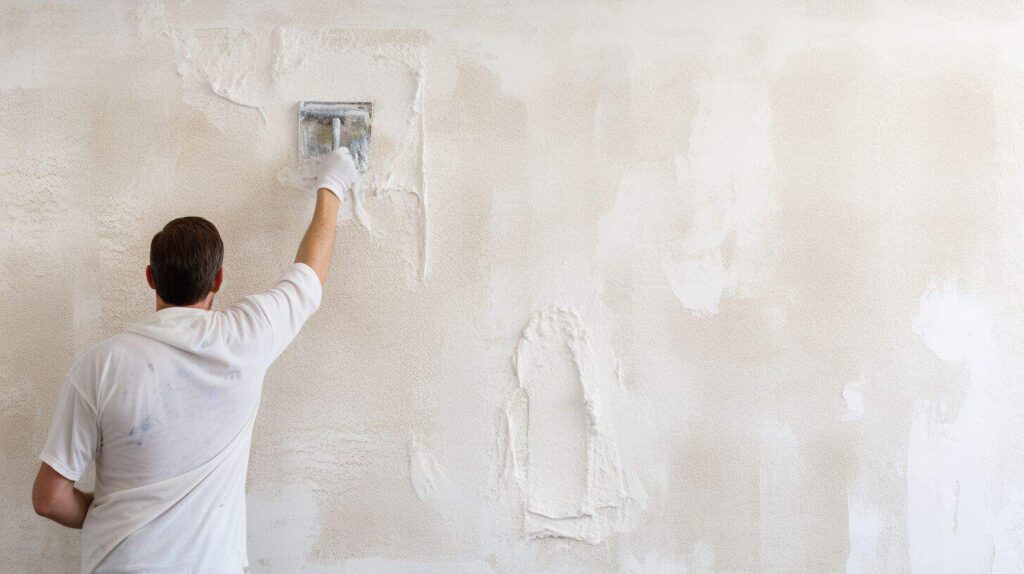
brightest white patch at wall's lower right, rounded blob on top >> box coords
[906,285,1007,574]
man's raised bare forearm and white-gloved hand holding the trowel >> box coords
[295,147,359,284]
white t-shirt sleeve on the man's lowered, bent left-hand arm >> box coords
[39,377,99,481]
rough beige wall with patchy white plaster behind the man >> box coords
[0,0,1024,574]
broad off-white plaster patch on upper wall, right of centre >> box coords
[596,71,774,315]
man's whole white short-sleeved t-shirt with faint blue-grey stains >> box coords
[40,263,322,574]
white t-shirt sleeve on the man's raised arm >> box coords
[230,263,324,361]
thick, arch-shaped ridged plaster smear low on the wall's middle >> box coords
[502,307,643,543]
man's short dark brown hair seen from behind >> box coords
[150,217,224,305]
